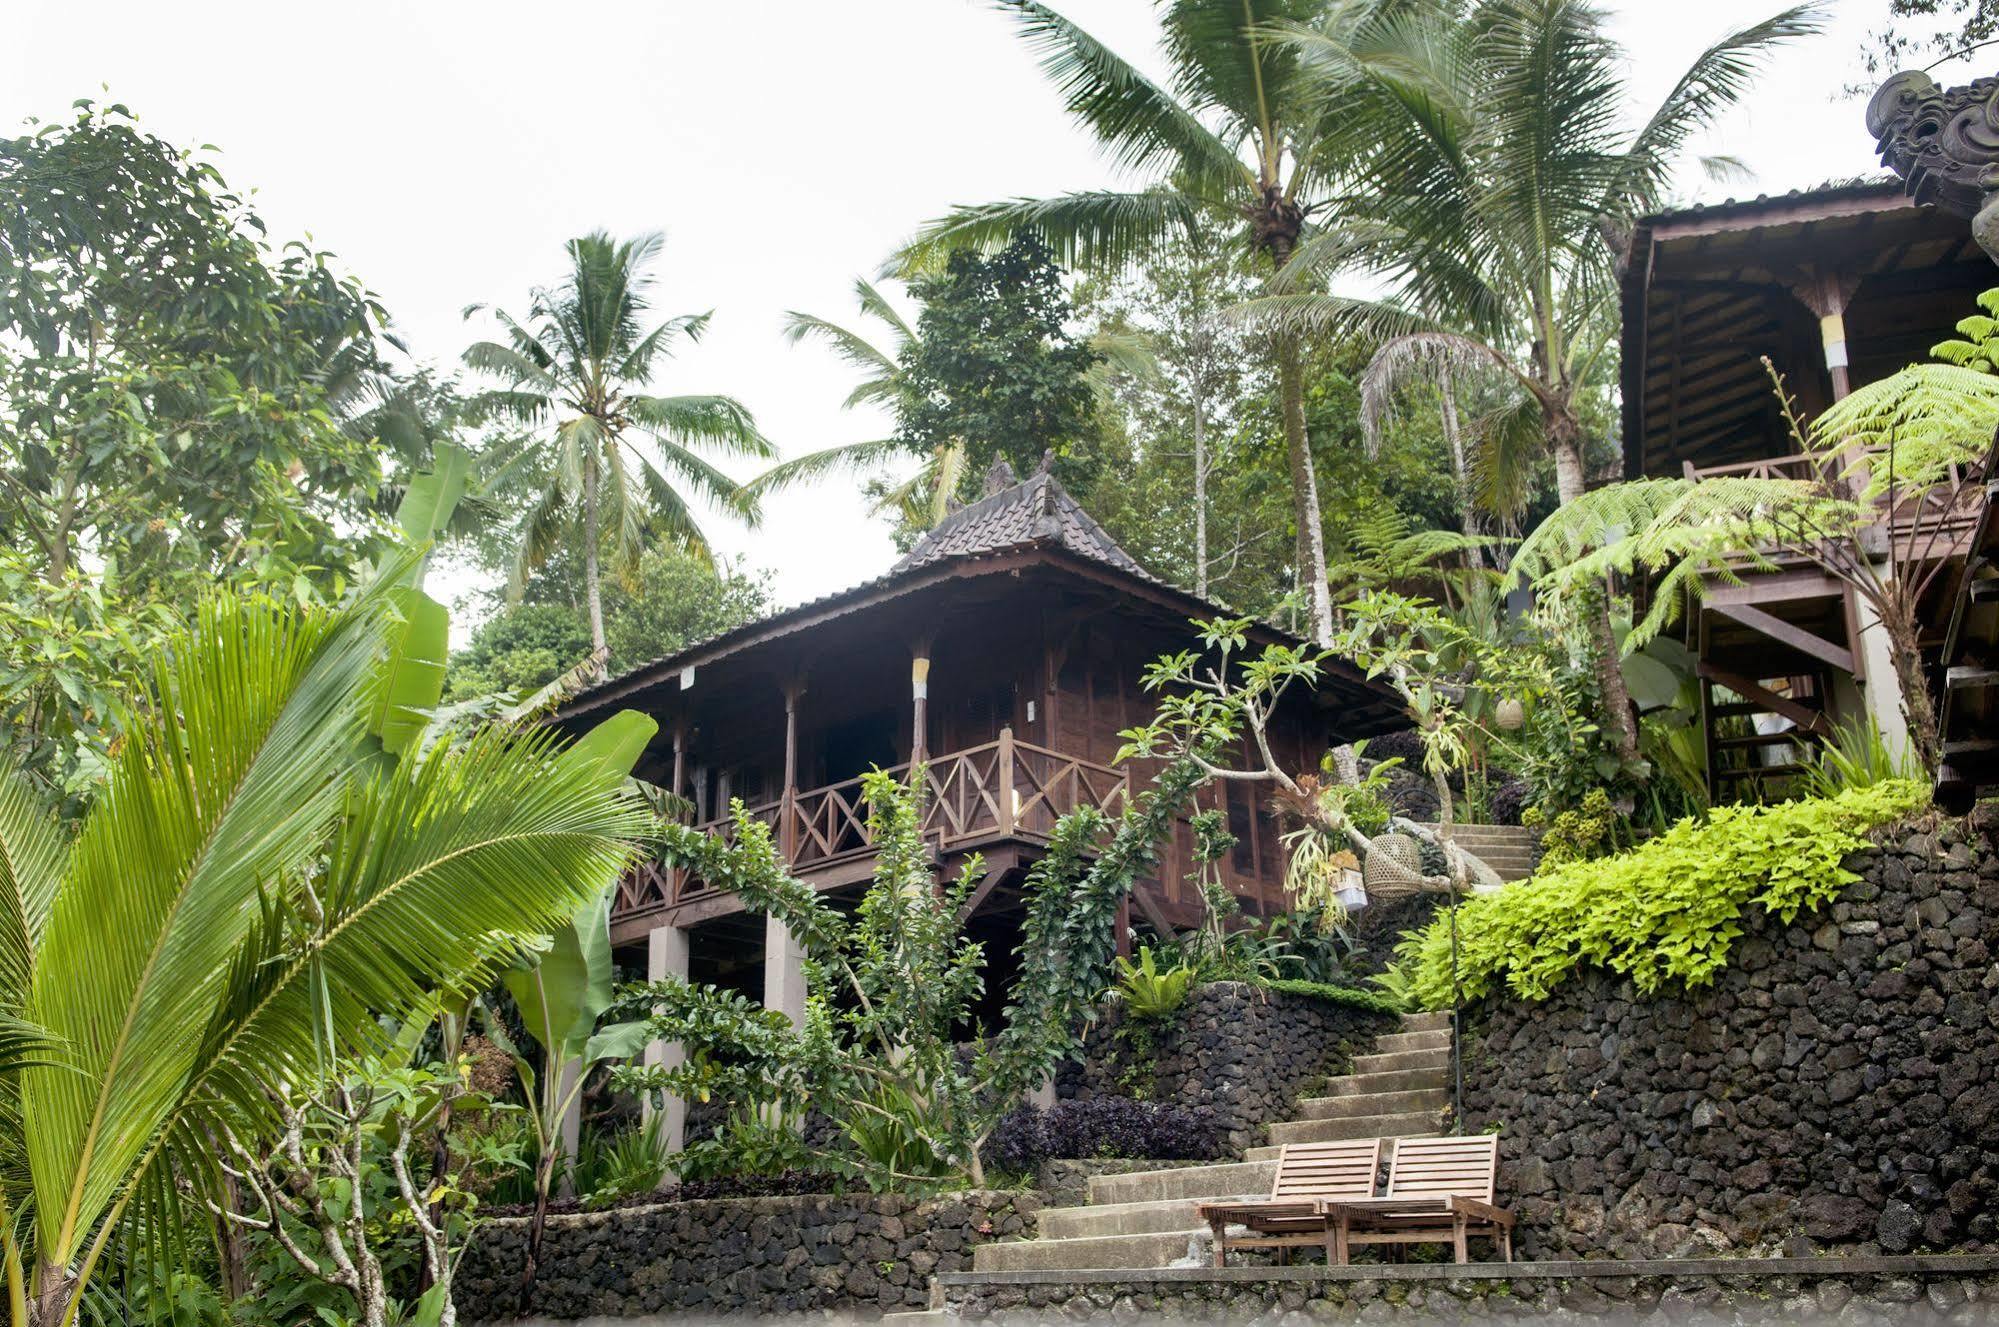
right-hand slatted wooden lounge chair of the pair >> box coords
[1325,1133,1513,1263]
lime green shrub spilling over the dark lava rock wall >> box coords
[1399,779,1929,1009]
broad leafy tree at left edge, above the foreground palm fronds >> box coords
[0,102,450,809]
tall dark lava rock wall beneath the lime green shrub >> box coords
[1463,815,1999,1259]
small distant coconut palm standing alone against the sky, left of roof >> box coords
[466,230,776,667]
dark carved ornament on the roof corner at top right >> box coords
[1867,70,1999,262]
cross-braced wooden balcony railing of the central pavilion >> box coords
[612,729,1131,915]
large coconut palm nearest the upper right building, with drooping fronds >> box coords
[1251,0,1817,757]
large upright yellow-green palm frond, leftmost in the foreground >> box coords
[22,594,384,1265]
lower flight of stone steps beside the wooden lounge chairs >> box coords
[972,1013,1451,1271]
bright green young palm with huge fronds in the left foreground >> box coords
[0,560,652,1327]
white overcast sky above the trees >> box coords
[0,0,1887,623]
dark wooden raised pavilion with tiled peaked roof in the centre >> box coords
[556,462,1405,1039]
